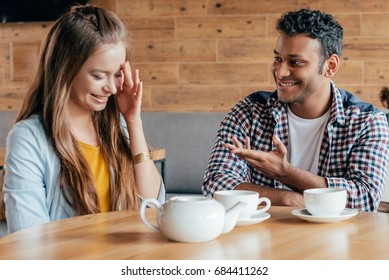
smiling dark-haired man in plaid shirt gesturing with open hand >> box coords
[203,9,389,211]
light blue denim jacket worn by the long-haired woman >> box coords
[0,115,165,237]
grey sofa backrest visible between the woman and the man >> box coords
[142,112,226,197]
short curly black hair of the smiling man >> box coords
[276,9,343,72]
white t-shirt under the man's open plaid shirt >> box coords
[288,107,330,174]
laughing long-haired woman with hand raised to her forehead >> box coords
[0,5,165,236]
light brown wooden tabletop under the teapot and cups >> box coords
[0,206,389,260]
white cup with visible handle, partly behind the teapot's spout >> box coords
[213,190,271,220]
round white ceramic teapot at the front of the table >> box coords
[140,195,244,242]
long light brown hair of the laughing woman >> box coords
[0,5,139,219]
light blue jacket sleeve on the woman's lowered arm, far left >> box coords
[3,123,50,233]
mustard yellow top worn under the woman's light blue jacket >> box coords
[78,142,111,212]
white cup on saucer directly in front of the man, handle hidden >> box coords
[304,188,347,217]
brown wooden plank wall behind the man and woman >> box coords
[0,0,389,112]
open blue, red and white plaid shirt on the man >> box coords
[203,83,389,211]
